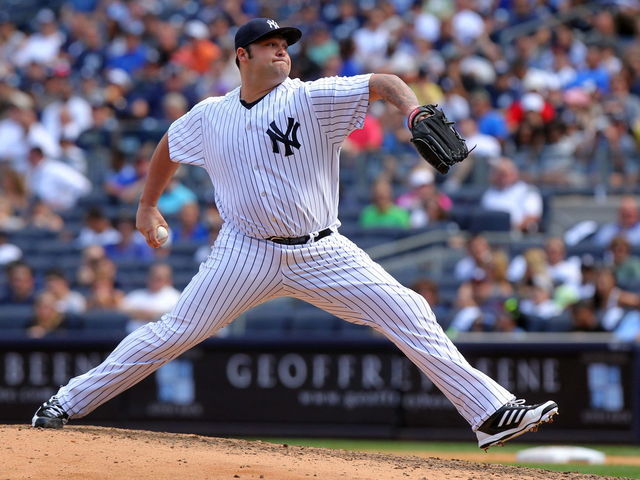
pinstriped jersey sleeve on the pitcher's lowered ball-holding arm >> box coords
[169,99,212,167]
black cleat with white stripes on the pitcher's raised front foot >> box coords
[476,399,558,451]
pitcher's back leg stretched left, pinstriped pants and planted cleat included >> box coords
[33,231,281,428]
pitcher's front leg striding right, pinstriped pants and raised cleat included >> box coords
[287,234,557,448]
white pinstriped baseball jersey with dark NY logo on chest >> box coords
[169,75,370,238]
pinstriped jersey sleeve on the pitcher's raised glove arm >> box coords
[307,73,371,142]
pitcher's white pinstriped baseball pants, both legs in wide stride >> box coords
[57,225,514,430]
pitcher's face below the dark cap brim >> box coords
[243,36,291,81]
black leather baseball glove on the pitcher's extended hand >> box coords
[409,105,469,175]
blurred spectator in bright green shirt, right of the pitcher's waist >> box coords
[360,177,410,228]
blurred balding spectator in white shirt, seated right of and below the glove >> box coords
[480,157,542,233]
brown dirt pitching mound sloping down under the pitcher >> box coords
[0,425,605,480]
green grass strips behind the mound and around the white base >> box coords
[254,438,640,479]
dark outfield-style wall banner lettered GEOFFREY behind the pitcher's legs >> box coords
[0,339,640,441]
